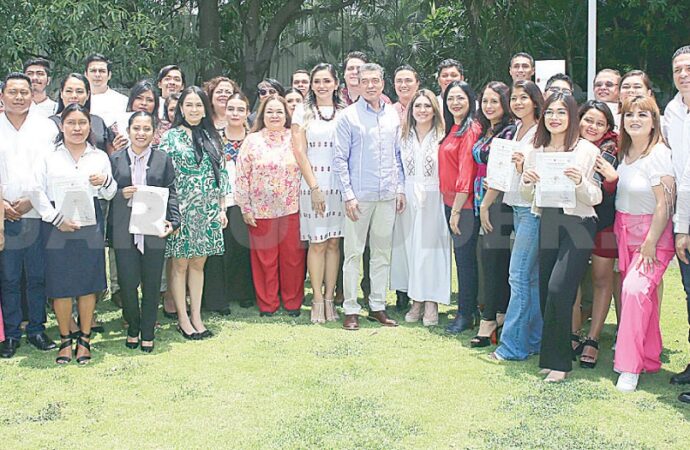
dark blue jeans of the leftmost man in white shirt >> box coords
[0,219,46,339]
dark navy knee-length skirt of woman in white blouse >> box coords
[43,198,106,298]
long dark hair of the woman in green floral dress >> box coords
[172,86,223,187]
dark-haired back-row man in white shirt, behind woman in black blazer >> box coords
[84,53,129,125]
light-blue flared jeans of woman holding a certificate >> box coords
[496,206,543,360]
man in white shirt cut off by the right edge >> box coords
[662,45,690,403]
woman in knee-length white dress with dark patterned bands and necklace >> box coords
[292,63,345,323]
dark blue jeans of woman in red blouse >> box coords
[445,205,479,317]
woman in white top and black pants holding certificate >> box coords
[520,93,601,382]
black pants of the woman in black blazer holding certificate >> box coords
[115,243,165,341]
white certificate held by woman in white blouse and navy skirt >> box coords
[50,176,96,227]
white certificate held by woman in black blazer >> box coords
[129,186,170,236]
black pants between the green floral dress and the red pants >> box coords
[202,206,256,311]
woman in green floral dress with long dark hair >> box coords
[160,86,230,339]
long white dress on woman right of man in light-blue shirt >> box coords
[391,130,451,305]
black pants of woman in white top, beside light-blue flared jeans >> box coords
[539,208,596,372]
